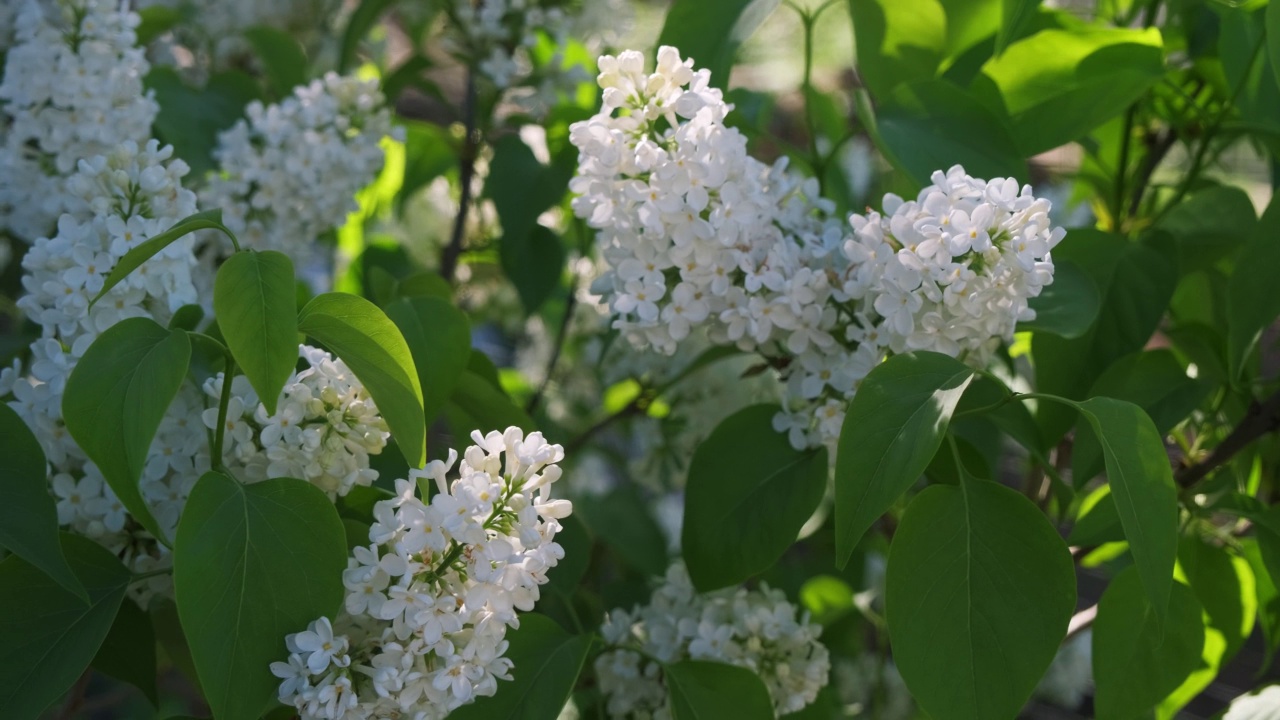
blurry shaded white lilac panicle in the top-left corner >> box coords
[0,0,159,242]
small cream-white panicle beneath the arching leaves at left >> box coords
[202,345,390,498]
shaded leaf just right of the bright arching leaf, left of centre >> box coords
[387,297,478,429]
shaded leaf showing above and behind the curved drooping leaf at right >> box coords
[1071,350,1208,487]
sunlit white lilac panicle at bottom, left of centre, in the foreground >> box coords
[271,428,572,720]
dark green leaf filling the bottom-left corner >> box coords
[0,534,129,720]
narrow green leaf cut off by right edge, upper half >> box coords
[1226,196,1280,380]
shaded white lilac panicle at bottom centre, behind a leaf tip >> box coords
[595,562,831,720]
